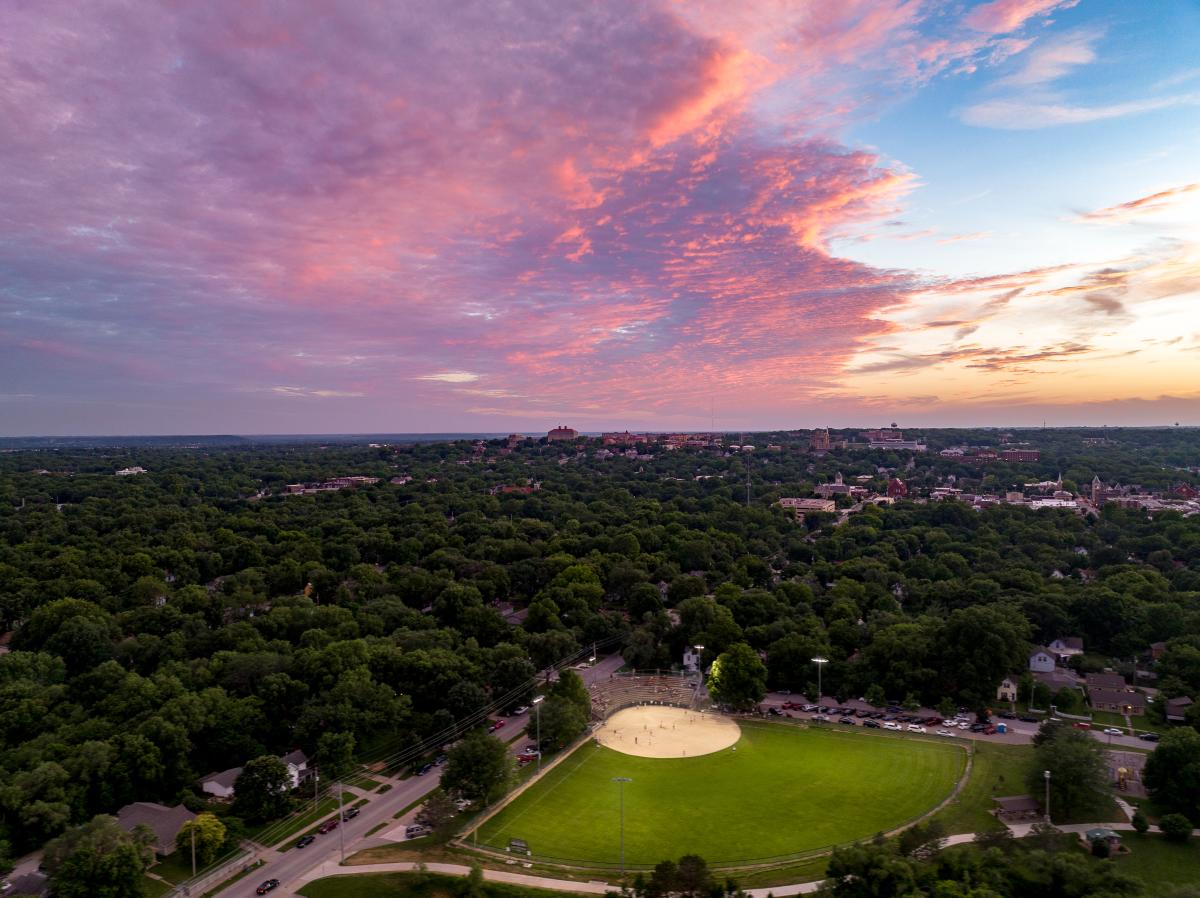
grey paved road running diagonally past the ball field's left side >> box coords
[236,655,624,898]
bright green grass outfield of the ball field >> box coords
[472,724,966,867]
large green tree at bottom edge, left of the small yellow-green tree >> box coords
[44,814,154,898]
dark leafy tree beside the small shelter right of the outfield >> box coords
[1028,724,1109,820]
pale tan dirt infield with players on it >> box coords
[595,705,742,758]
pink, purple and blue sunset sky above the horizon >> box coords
[0,0,1200,435]
